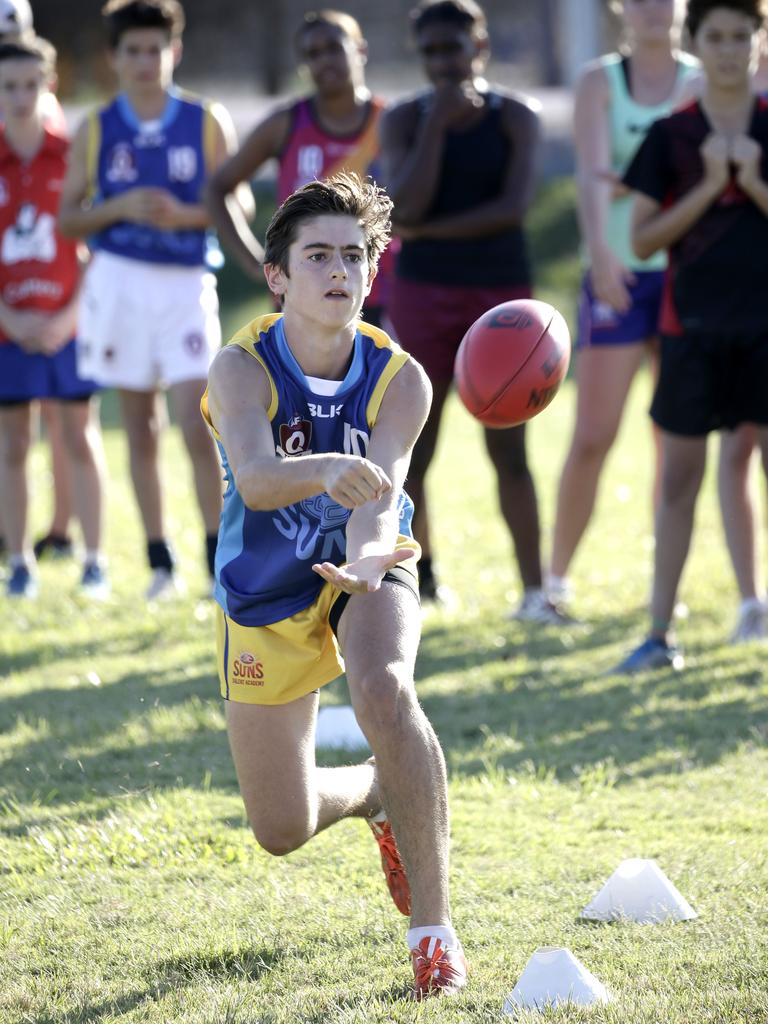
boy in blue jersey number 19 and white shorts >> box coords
[60,0,249,600]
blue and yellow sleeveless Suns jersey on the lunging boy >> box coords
[201,313,414,626]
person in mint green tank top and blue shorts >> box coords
[547,0,765,639]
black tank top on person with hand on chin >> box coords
[395,93,530,287]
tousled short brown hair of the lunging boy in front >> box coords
[264,172,392,273]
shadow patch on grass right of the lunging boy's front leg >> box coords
[418,612,768,784]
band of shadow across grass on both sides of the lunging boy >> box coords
[0,598,768,811]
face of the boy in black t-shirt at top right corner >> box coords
[693,6,761,89]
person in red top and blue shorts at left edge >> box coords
[0,34,108,597]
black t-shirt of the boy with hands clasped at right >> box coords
[624,97,768,334]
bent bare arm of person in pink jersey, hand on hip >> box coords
[206,109,291,280]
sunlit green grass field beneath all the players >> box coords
[0,180,768,1024]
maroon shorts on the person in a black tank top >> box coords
[387,276,530,381]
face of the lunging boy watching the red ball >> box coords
[264,214,375,330]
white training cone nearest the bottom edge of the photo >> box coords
[504,946,609,1014]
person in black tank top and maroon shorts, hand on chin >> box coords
[382,0,560,623]
